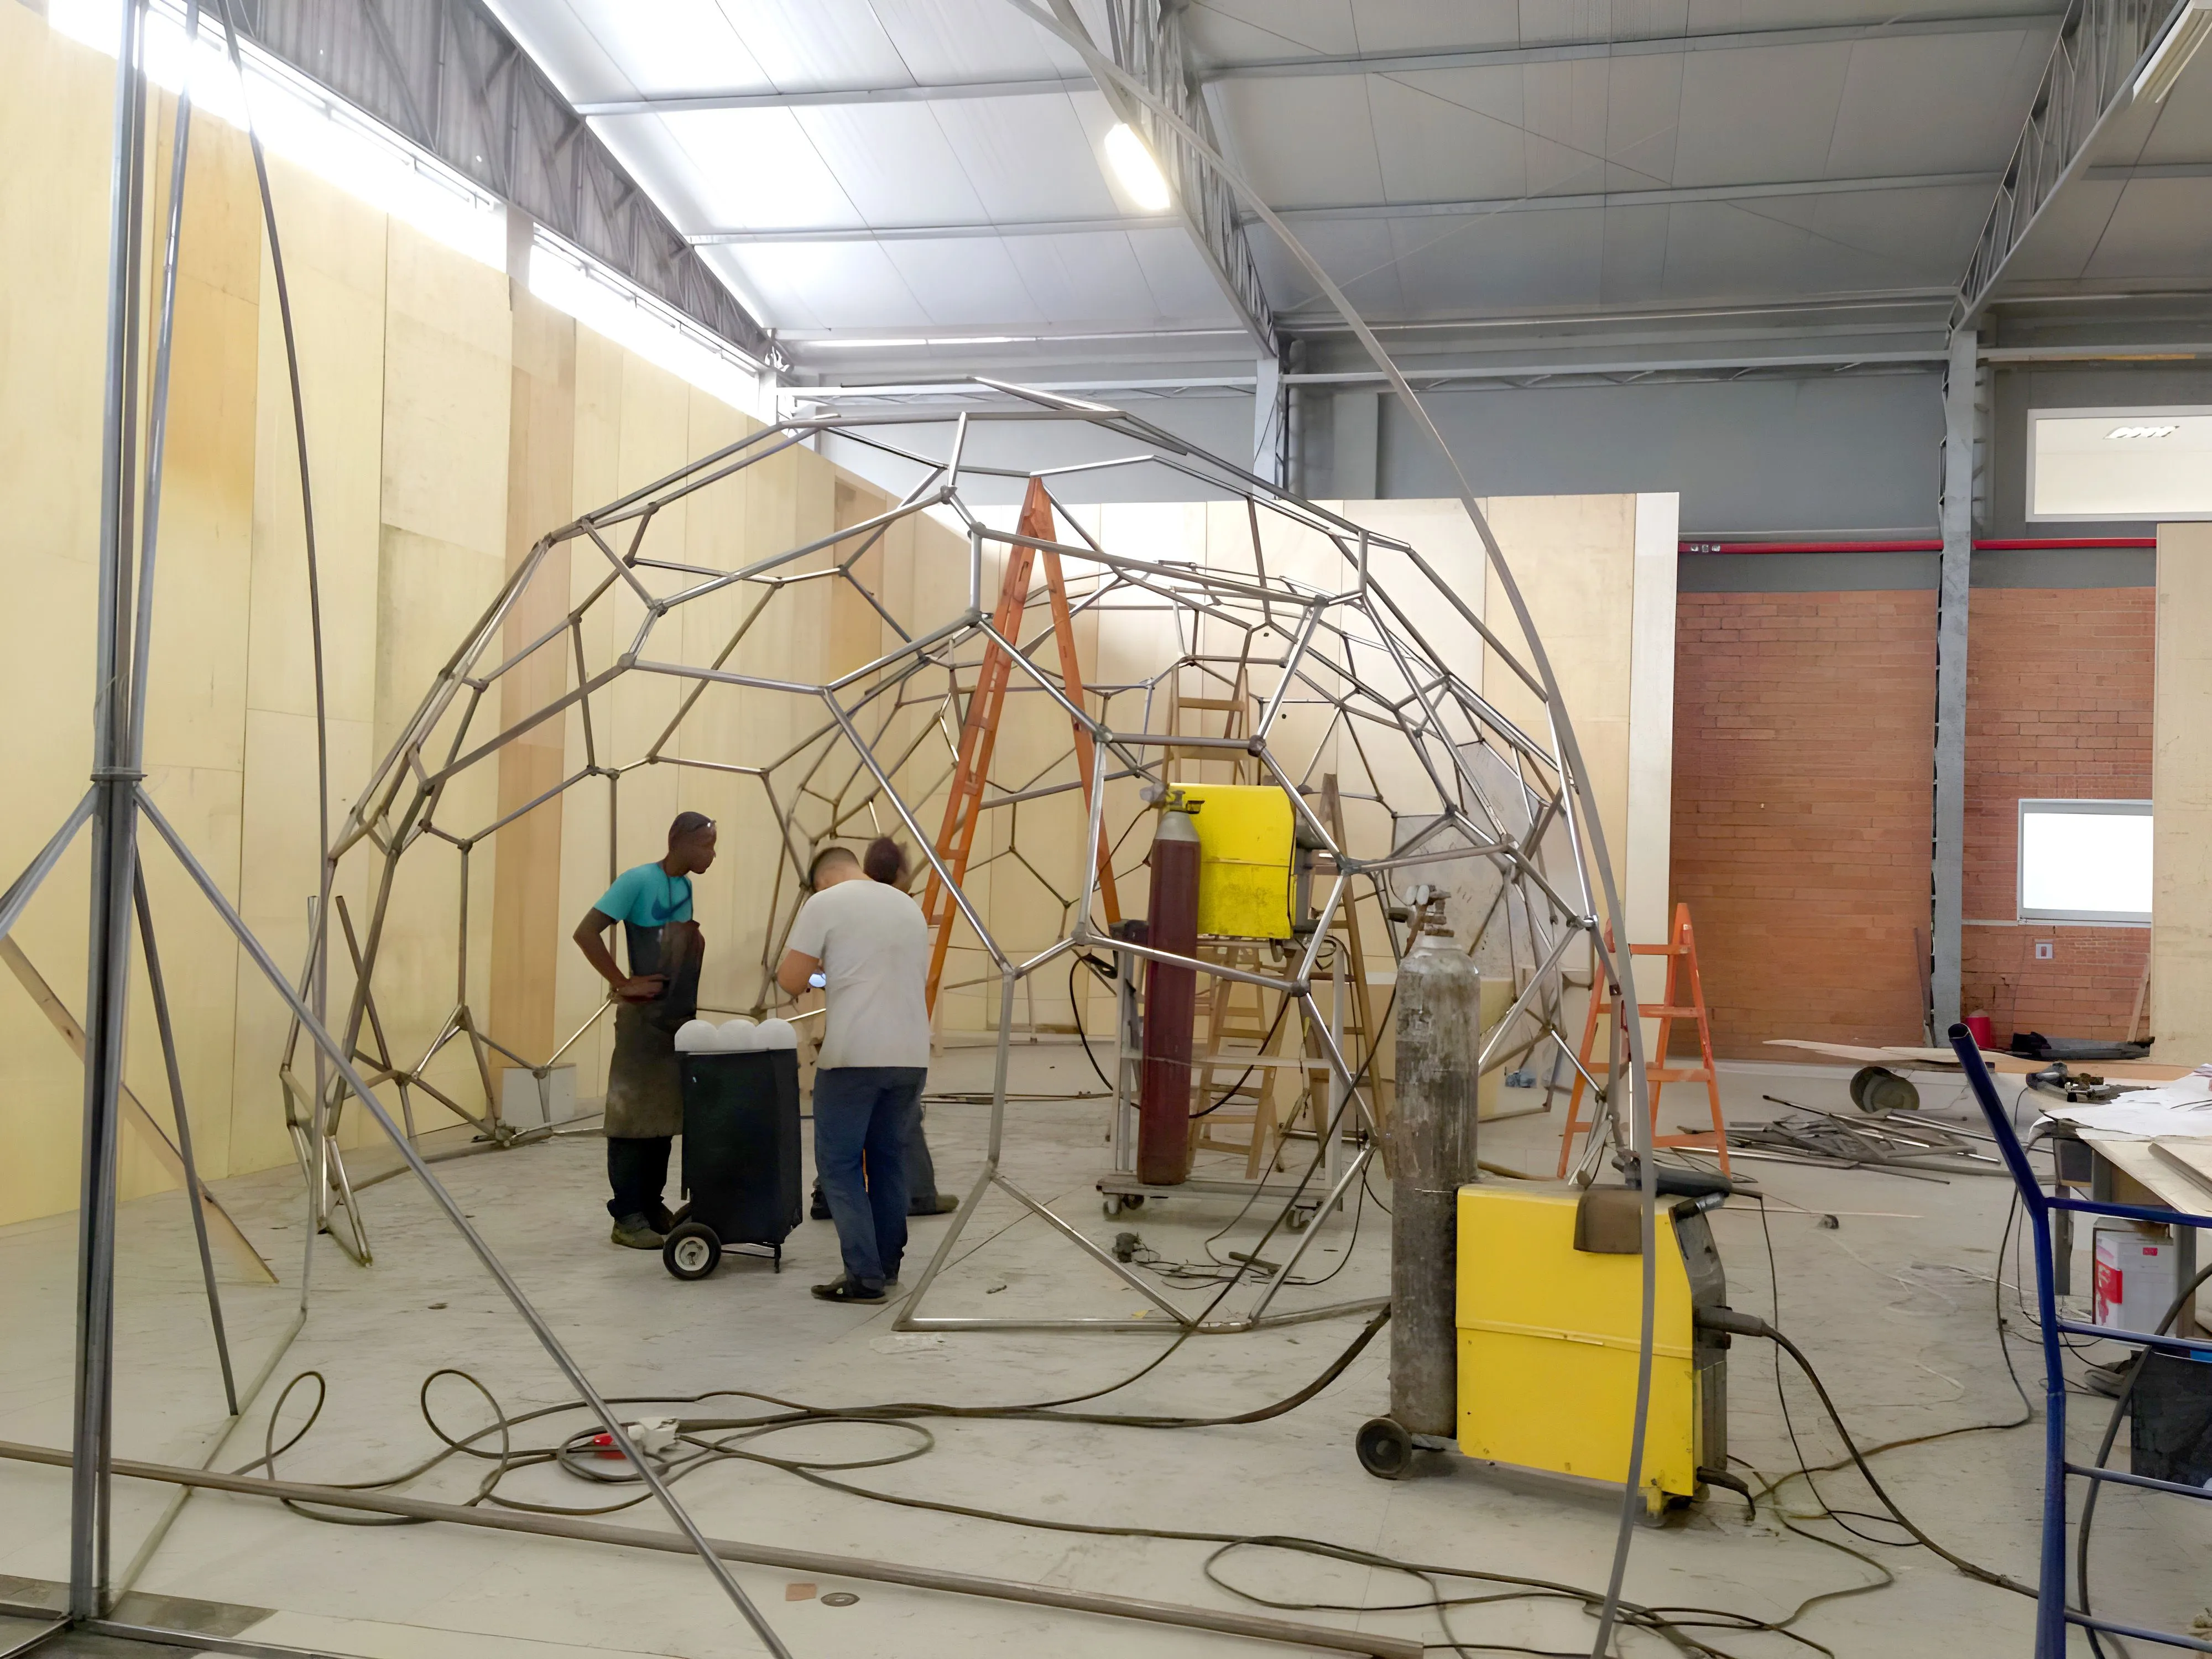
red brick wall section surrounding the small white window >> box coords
[1962,588,2154,1042]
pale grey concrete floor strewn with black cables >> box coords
[0,1046,2212,1659]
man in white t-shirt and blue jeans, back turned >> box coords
[776,847,929,1303]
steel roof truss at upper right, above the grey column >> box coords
[1960,0,2183,327]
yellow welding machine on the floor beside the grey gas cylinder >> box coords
[1455,1170,1728,1513]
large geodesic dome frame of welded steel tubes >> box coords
[285,383,1604,1329]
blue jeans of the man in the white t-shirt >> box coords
[814,1066,929,1290]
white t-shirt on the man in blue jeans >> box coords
[790,876,929,1071]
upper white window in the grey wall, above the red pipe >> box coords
[2028,409,2212,522]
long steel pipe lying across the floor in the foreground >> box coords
[0,1440,1422,1659]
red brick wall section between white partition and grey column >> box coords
[1672,591,1938,1060]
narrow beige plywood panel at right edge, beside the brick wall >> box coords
[2150,524,2212,1066]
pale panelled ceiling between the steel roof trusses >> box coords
[495,0,2212,365]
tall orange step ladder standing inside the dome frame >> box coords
[922,478,1121,1013]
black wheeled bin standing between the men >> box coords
[661,1048,803,1279]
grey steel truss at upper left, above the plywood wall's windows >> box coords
[239,0,787,369]
